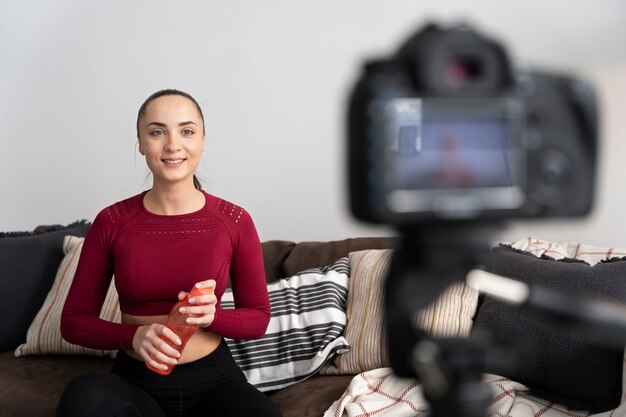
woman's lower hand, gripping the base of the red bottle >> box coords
[133,323,182,370]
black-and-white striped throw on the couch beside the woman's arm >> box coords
[222,257,350,391]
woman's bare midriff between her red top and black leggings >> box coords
[122,313,222,364]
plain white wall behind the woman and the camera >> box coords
[0,0,626,246]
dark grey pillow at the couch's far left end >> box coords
[0,222,89,351]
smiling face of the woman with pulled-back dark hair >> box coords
[139,95,204,185]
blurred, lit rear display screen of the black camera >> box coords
[385,98,524,217]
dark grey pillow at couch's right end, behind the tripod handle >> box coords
[472,245,626,413]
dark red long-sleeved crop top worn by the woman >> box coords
[61,192,270,350]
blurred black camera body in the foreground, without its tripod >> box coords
[347,25,598,226]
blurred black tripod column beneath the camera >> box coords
[385,225,500,417]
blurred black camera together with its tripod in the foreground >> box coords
[347,24,598,417]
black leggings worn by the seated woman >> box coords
[56,340,281,417]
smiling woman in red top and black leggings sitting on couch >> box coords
[57,90,280,417]
